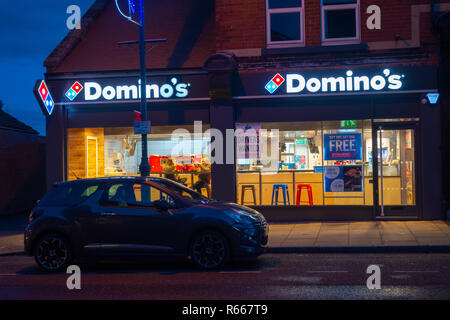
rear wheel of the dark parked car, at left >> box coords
[34,234,73,272]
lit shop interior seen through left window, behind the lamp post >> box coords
[67,126,211,196]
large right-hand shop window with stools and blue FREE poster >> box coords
[236,120,373,206]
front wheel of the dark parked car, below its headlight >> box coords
[190,230,230,269]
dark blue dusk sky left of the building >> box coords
[0,0,95,135]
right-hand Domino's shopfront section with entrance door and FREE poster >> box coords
[233,66,441,221]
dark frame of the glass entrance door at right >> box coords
[372,119,423,219]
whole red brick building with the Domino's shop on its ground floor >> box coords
[37,0,450,220]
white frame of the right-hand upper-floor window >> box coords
[320,0,361,46]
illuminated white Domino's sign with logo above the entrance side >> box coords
[265,69,405,94]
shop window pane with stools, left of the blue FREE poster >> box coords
[236,122,323,206]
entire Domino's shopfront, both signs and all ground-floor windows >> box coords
[35,62,441,221]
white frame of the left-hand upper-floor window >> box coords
[266,0,305,48]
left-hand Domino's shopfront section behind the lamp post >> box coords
[35,70,215,196]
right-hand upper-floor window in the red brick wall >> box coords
[321,0,360,45]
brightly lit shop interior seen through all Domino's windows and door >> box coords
[67,119,417,206]
